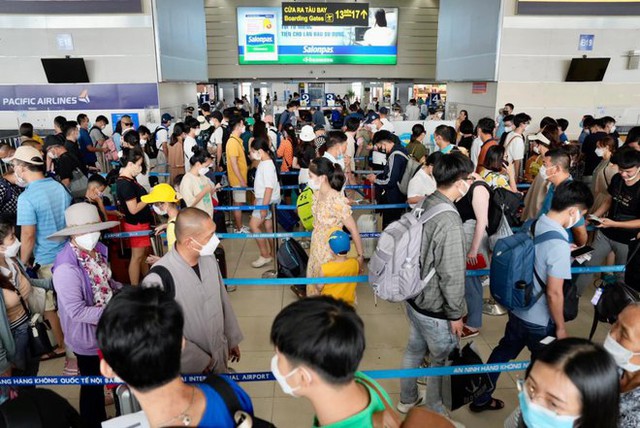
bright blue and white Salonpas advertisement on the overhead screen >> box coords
[238,7,398,65]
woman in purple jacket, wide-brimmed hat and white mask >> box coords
[49,202,122,428]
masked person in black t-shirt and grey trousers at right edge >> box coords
[578,148,640,294]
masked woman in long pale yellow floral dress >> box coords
[304,157,364,297]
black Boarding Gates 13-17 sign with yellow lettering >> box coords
[282,2,369,27]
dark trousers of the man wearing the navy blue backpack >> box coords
[473,312,556,406]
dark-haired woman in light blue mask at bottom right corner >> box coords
[504,338,620,428]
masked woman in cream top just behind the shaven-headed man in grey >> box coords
[180,146,216,218]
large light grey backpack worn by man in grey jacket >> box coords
[369,203,457,302]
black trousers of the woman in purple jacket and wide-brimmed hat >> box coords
[76,354,107,428]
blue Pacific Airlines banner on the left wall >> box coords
[0,83,158,111]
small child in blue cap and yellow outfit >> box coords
[318,229,360,306]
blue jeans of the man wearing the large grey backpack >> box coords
[400,304,458,414]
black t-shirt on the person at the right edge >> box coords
[601,174,640,244]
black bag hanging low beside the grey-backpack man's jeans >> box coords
[442,342,493,411]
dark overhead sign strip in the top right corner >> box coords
[518,0,640,15]
